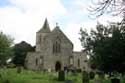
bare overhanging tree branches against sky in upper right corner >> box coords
[88,0,125,17]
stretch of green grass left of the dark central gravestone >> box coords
[0,69,62,83]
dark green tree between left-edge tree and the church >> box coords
[13,41,34,66]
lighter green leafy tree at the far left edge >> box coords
[0,32,13,65]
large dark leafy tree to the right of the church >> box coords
[80,23,125,72]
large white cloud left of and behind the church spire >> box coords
[0,0,66,45]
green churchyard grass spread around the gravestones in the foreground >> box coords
[0,68,123,83]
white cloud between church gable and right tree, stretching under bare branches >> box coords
[64,16,122,51]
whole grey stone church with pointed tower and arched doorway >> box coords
[25,19,88,71]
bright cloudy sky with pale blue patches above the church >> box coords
[0,0,121,51]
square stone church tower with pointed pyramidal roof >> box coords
[36,18,51,52]
